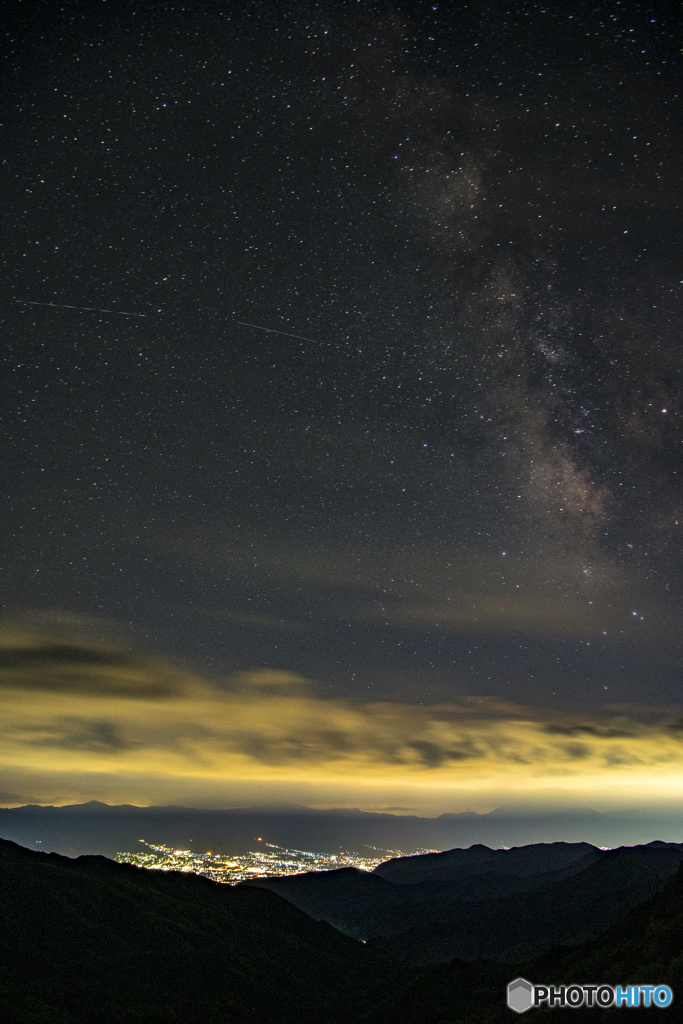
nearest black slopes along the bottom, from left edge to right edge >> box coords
[0,842,683,1024]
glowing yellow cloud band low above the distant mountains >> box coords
[0,618,683,811]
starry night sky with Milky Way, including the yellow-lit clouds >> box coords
[0,0,683,813]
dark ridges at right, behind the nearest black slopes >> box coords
[243,843,683,967]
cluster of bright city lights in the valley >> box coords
[116,839,433,886]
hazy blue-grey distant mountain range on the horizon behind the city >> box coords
[0,801,683,857]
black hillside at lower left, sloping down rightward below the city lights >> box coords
[0,841,397,1024]
